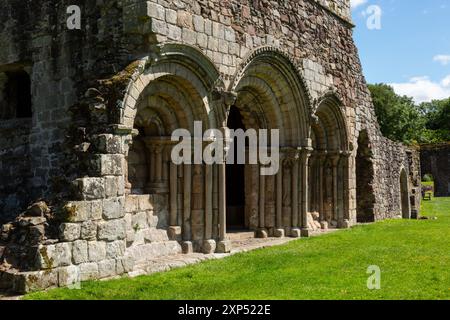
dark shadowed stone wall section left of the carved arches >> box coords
[0,0,135,218]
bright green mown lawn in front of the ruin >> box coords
[25,198,450,300]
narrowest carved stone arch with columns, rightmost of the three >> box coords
[309,93,350,227]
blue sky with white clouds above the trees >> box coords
[351,0,450,102]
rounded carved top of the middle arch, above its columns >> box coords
[231,47,312,147]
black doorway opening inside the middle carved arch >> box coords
[226,106,246,231]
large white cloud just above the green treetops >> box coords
[390,75,450,103]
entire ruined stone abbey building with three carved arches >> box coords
[0,0,421,292]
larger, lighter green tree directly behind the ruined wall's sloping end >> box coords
[369,83,427,144]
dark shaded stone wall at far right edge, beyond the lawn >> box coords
[420,143,450,197]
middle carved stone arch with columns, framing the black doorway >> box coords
[227,47,311,237]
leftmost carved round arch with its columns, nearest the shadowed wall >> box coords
[121,44,229,252]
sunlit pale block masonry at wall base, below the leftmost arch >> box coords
[0,195,181,293]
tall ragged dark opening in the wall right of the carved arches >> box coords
[356,130,375,223]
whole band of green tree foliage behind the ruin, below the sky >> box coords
[369,84,450,144]
